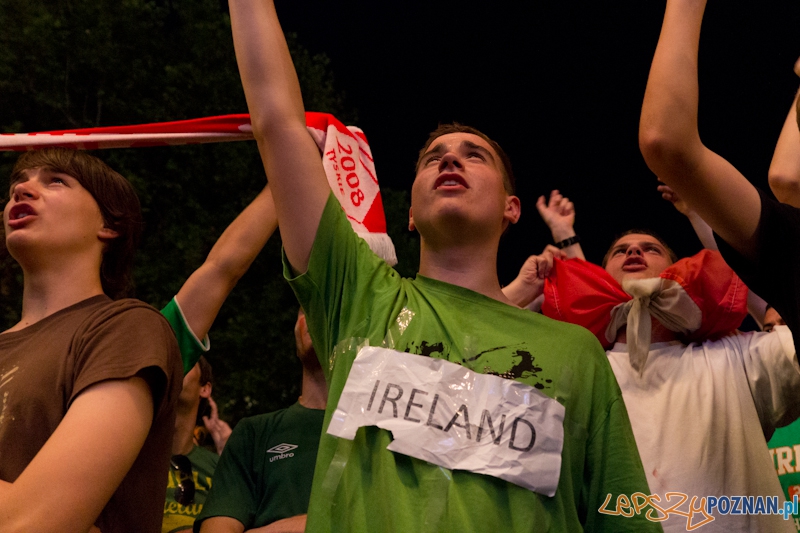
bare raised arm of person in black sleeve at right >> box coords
[639,0,761,257]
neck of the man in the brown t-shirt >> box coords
[6,264,103,332]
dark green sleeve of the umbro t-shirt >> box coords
[194,420,256,532]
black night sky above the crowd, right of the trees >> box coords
[276,0,800,283]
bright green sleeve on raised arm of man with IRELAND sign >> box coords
[283,194,402,377]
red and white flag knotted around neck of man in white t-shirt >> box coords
[542,250,747,372]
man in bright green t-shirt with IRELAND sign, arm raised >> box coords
[230,0,661,532]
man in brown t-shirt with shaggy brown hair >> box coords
[0,149,182,532]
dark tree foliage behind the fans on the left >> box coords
[0,0,418,421]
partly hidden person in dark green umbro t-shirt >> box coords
[194,310,328,533]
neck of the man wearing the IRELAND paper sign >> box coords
[419,239,514,305]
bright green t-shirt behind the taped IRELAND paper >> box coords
[284,196,661,533]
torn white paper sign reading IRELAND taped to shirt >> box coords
[328,347,564,496]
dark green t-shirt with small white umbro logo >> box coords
[195,403,325,531]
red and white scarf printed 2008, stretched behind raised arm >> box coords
[0,112,397,265]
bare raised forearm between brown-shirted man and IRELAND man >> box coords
[175,186,278,339]
